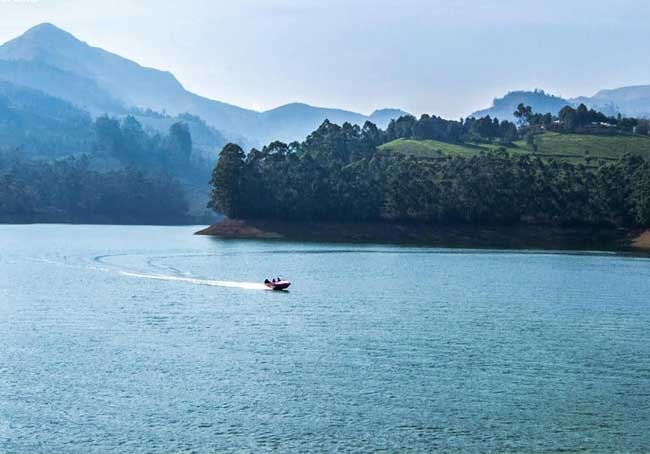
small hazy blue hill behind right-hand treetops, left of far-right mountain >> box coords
[469,90,571,120]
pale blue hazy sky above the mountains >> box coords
[0,0,650,118]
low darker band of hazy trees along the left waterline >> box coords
[0,152,187,224]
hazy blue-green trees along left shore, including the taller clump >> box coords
[0,111,208,224]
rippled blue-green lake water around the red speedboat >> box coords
[0,225,650,453]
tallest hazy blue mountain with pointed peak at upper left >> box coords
[0,23,255,135]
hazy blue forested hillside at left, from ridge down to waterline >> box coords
[0,81,225,223]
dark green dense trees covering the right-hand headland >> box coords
[210,105,650,231]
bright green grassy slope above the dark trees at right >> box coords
[380,133,650,163]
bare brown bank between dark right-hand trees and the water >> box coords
[195,218,650,252]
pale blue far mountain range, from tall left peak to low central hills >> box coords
[0,23,404,145]
